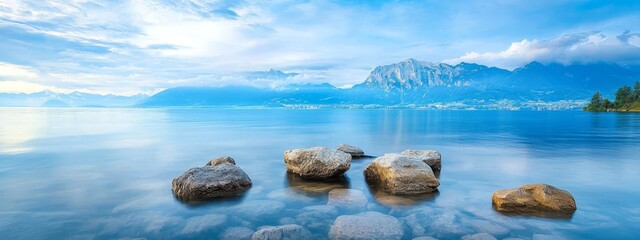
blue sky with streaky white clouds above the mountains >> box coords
[0,0,640,95]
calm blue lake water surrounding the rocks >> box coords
[0,108,640,239]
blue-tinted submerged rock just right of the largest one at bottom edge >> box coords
[404,208,473,239]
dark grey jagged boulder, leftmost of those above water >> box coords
[171,163,252,202]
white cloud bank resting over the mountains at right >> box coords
[445,32,640,69]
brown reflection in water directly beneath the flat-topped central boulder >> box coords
[285,172,350,195]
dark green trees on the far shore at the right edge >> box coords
[584,81,640,112]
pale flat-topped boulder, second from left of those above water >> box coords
[284,147,351,179]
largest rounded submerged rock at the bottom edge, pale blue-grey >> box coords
[329,212,404,240]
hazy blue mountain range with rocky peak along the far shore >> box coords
[0,59,640,109]
